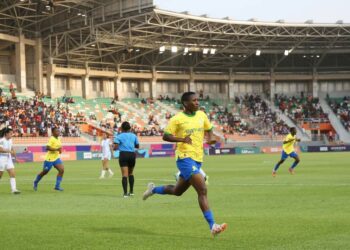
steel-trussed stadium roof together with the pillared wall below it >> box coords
[0,0,350,99]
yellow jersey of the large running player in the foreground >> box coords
[164,111,213,162]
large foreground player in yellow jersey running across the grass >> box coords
[143,92,227,236]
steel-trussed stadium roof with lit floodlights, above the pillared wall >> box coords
[0,0,350,71]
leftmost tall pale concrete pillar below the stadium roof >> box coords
[16,34,27,92]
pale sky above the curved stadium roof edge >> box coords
[154,0,350,23]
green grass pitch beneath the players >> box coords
[0,153,350,250]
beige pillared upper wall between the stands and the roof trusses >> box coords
[39,65,350,99]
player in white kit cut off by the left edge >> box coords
[0,128,21,194]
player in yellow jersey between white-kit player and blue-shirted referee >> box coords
[33,127,64,191]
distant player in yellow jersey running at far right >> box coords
[272,127,300,177]
